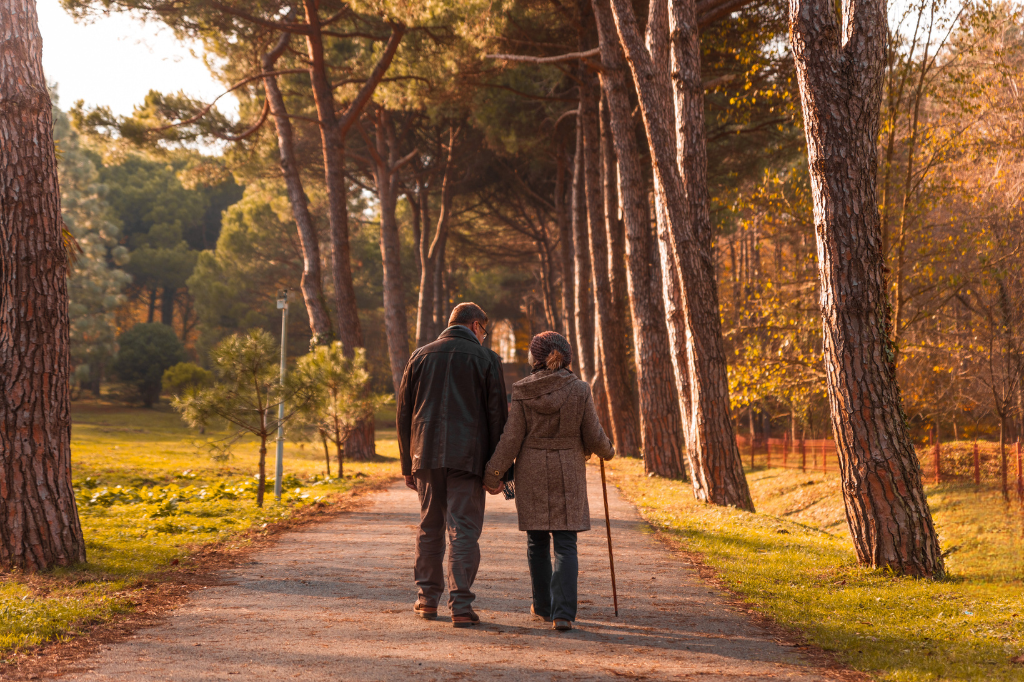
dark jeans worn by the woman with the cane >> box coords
[526,530,580,621]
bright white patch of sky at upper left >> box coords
[37,0,236,115]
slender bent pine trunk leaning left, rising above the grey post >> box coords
[262,33,331,340]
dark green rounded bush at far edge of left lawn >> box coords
[114,324,185,408]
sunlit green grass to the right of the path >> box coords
[609,459,1024,681]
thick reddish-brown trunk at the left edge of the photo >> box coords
[0,0,85,570]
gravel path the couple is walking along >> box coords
[61,467,836,682]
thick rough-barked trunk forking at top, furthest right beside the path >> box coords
[790,0,944,577]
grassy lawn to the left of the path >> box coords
[0,400,398,654]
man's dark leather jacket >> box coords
[397,326,509,476]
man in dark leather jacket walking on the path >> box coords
[397,303,508,628]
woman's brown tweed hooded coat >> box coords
[483,370,615,530]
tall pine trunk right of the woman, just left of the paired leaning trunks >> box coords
[593,0,686,478]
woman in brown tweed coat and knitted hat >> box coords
[483,332,615,630]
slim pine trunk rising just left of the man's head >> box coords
[374,109,417,394]
